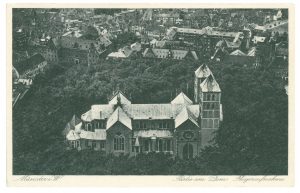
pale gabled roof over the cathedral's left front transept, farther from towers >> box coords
[106,107,132,129]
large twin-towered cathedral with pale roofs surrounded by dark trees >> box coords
[63,64,223,159]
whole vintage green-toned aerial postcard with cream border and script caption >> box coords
[7,4,294,186]
